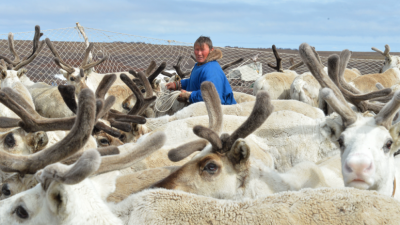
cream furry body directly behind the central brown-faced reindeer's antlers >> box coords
[149,111,342,172]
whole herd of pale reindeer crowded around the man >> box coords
[0,26,400,224]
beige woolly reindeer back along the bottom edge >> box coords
[111,188,400,224]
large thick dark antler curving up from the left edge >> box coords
[0,89,96,174]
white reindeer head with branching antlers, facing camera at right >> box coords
[299,43,400,194]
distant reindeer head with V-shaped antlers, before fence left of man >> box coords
[46,38,108,94]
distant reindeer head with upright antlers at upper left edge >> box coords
[0,25,44,85]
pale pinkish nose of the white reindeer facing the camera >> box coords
[344,154,374,175]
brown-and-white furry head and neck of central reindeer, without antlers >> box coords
[155,139,343,199]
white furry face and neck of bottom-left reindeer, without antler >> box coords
[0,170,123,225]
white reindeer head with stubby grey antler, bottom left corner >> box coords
[0,150,121,224]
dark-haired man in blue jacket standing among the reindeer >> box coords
[166,36,236,105]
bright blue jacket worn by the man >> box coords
[181,61,236,105]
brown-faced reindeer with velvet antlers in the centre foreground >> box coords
[154,82,337,199]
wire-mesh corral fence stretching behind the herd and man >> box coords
[0,27,383,94]
